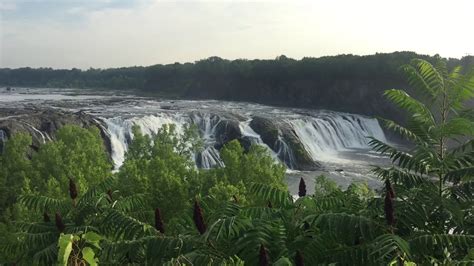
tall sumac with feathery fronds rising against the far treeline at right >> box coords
[372,59,474,196]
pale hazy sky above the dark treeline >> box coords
[0,0,474,68]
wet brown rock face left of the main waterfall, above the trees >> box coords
[0,108,111,152]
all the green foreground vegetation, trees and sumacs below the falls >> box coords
[0,60,474,265]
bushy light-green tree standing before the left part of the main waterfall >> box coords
[118,125,199,221]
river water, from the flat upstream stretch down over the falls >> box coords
[0,89,387,191]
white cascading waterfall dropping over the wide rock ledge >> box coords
[103,105,386,169]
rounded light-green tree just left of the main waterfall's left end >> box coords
[32,125,112,197]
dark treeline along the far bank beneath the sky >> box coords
[0,52,474,118]
